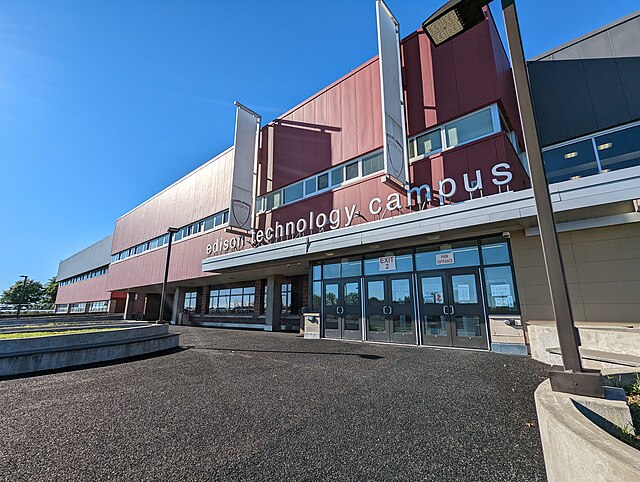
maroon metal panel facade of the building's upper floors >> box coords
[61,13,529,299]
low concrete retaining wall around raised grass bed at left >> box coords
[0,325,180,377]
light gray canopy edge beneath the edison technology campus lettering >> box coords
[202,166,640,272]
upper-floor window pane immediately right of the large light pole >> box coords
[542,139,599,184]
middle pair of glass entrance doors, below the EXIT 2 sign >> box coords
[365,274,416,343]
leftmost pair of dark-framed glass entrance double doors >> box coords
[323,278,362,340]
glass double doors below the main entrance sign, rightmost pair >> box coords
[418,268,489,349]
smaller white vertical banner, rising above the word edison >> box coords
[229,102,261,230]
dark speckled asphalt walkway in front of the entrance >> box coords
[0,327,546,481]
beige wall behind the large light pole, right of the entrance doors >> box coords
[511,224,640,323]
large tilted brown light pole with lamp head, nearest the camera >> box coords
[422,0,604,397]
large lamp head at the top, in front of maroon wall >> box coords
[422,0,489,47]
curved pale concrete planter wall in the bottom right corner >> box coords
[535,380,640,482]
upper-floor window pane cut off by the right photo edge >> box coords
[595,126,640,172]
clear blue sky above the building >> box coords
[0,0,639,290]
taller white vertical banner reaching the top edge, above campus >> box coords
[376,0,409,187]
